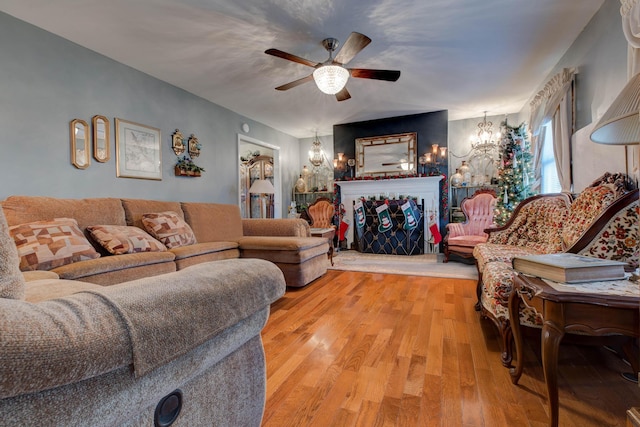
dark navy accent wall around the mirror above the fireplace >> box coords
[333,110,449,179]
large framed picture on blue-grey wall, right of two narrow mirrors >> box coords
[115,118,162,180]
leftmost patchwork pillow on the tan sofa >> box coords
[9,218,100,271]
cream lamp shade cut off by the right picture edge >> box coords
[591,73,640,145]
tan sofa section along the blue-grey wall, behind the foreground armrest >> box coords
[0,196,329,287]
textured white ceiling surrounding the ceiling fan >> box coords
[0,0,603,138]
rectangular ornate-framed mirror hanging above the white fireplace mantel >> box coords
[356,132,418,177]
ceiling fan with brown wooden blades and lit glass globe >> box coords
[264,32,400,101]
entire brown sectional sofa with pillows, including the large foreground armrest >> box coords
[0,196,328,427]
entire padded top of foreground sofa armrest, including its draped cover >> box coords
[0,259,286,399]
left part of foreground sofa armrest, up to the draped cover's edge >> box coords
[0,293,132,399]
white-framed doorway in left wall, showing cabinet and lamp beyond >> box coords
[237,134,282,218]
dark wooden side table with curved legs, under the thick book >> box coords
[509,274,640,427]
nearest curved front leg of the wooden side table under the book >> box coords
[542,301,564,427]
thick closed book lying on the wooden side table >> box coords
[512,253,626,283]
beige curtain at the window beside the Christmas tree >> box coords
[529,68,575,191]
